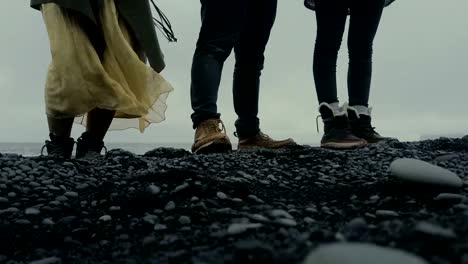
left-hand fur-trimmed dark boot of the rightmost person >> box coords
[319,103,367,149]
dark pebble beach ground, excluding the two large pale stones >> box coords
[0,139,468,264]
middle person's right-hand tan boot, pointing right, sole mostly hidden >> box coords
[237,131,296,149]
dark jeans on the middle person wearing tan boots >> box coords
[191,0,277,137]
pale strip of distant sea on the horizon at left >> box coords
[0,143,191,156]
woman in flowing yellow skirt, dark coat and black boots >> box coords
[31,0,172,158]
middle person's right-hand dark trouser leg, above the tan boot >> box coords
[233,0,277,138]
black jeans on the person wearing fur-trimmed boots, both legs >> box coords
[313,0,385,106]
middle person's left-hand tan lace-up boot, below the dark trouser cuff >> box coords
[192,118,232,154]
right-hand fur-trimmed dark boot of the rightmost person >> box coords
[347,105,390,143]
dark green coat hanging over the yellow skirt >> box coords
[31,0,165,72]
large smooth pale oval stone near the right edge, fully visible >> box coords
[390,158,463,188]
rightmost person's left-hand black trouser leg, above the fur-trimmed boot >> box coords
[313,0,348,104]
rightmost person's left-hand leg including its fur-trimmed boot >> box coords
[314,0,366,149]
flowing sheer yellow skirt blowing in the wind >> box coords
[42,0,173,132]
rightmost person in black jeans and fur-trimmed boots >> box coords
[305,0,393,149]
